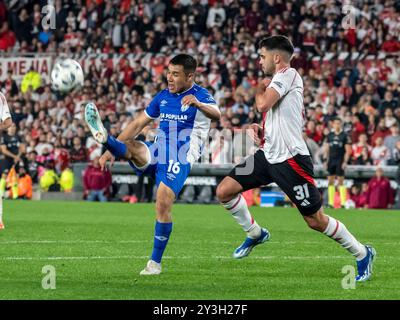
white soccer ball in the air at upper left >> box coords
[51,59,84,93]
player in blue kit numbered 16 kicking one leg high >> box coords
[85,54,221,275]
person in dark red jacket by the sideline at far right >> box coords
[365,168,394,209]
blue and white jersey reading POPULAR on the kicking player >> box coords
[145,84,218,164]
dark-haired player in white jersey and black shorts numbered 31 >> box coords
[217,36,376,281]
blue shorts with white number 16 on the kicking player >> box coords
[128,141,191,199]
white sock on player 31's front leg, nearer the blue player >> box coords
[222,194,261,239]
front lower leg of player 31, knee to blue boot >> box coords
[217,177,270,259]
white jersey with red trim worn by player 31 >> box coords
[261,67,310,163]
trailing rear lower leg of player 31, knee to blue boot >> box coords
[303,208,376,282]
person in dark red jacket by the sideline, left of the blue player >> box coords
[83,157,111,202]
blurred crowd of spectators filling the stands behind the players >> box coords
[0,0,400,202]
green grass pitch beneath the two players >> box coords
[0,201,400,300]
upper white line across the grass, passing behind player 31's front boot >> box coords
[0,239,400,246]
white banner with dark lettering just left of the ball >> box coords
[0,56,52,83]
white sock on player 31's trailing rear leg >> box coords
[324,216,367,261]
